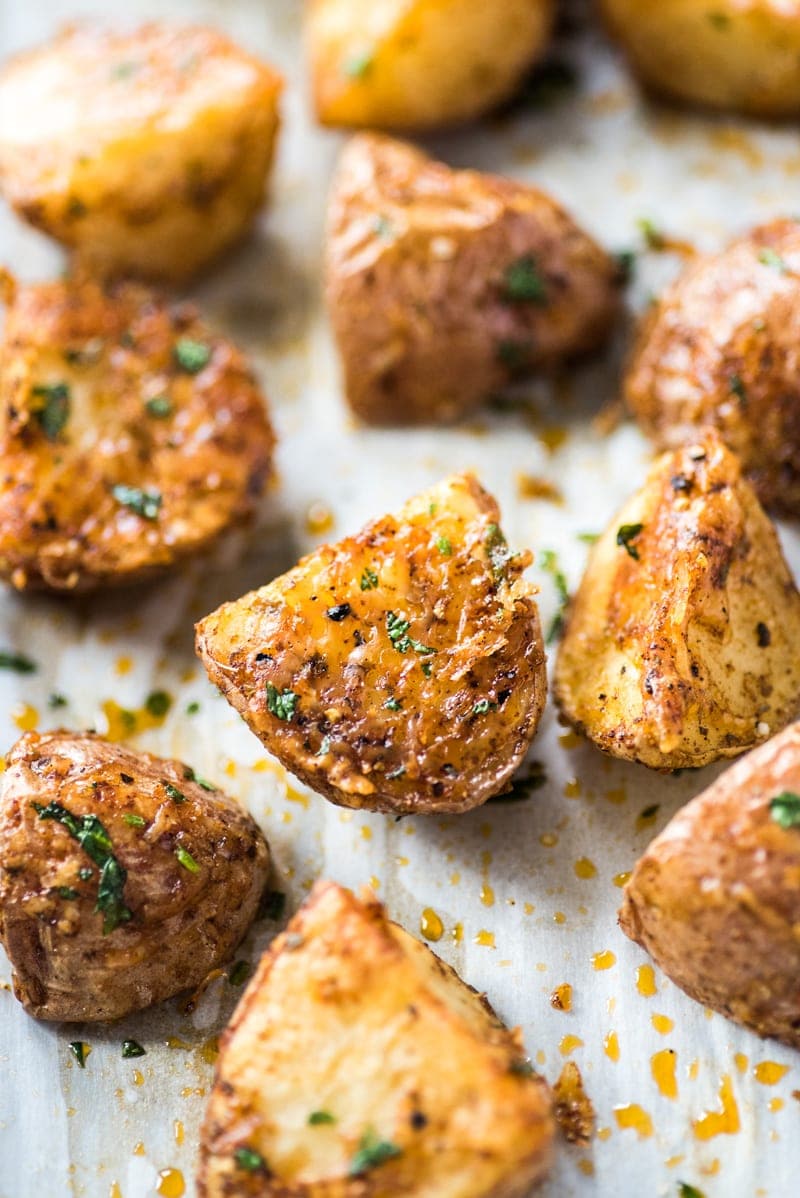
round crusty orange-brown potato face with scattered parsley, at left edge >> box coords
[0,270,273,591]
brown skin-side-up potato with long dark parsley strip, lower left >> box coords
[0,732,269,1022]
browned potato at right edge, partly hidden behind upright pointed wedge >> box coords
[625,220,800,516]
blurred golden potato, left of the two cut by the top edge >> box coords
[305,0,556,129]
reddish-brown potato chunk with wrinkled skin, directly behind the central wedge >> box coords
[326,133,620,424]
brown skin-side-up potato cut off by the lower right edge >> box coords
[619,724,800,1048]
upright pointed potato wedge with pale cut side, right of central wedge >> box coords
[554,434,800,769]
